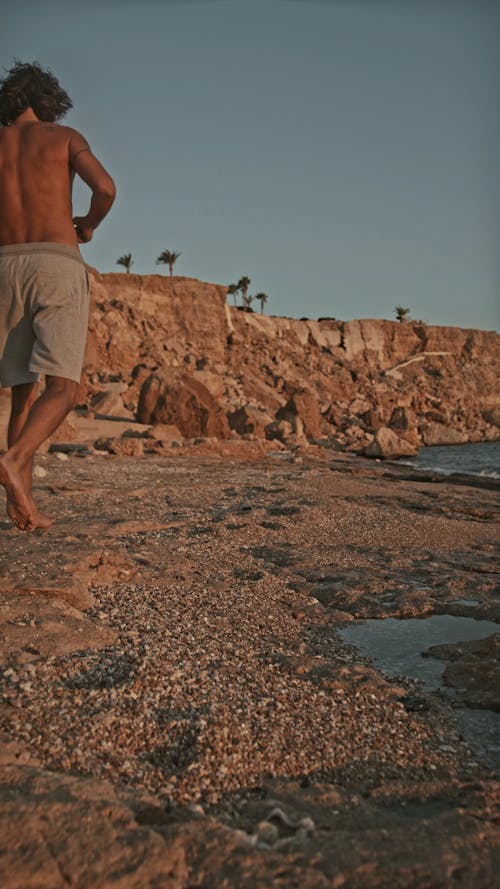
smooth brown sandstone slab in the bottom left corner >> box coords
[0,764,188,889]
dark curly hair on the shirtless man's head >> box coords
[0,59,73,126]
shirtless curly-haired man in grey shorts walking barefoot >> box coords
[0,62,115,531]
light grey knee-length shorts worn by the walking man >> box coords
[0,242,89,387]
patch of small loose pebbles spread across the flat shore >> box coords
[0,454,483,820]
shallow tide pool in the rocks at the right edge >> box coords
[340,614,500,771]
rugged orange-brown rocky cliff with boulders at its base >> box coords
[83,271,500,456]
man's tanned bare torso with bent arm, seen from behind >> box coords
[0,120,113,247]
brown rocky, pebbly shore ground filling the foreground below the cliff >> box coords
[0,450,500,889]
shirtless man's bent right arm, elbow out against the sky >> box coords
[69,130,116,244]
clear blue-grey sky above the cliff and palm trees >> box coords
[0,0,500,328]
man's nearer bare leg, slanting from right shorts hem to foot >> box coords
[0,377,79,531]
